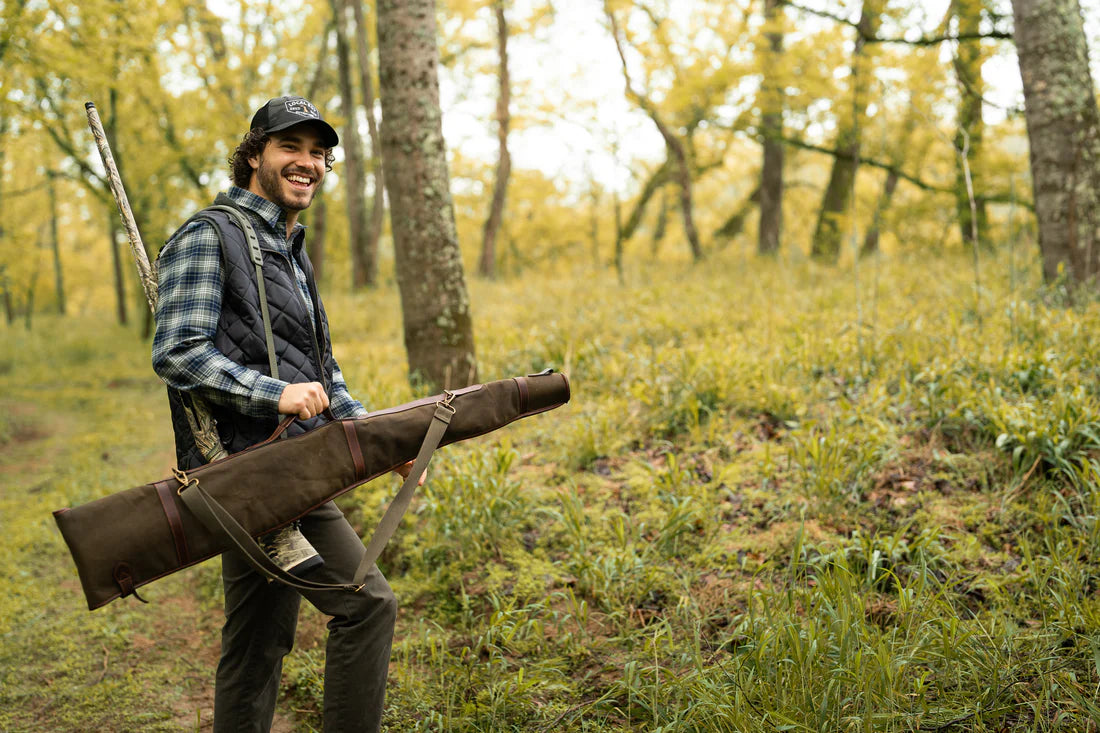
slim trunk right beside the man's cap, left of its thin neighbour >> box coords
[332,0,377,289]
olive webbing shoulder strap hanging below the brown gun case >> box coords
[176,396,454,592]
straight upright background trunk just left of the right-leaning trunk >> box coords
[757,0,783,254]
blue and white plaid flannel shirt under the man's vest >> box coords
[153,186,366,417]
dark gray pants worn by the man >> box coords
[213,502,397,733]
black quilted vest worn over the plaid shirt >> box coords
[168,194,332,470]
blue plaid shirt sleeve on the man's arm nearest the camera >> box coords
[153,221,288,417]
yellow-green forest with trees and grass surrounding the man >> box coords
[0,0,1100,733]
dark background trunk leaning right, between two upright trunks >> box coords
[811,0,882,262]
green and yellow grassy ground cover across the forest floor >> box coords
[0,248,1100,732]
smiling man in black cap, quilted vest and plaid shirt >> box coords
[153,97,404,733]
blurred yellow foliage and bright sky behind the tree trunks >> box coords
[0,0,1073,322]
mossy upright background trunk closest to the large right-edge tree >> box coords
[954,0,989,245]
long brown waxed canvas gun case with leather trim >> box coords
[54,373,570,610]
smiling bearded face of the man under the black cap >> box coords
[249,123,326,211]
